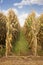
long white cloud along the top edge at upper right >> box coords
[14,0,43,8]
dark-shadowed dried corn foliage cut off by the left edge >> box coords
[0,12,7,45]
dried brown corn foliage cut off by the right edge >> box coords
[38,14,43,49]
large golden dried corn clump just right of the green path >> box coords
[24,12,40,55]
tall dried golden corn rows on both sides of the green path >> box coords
[0,9,43,57]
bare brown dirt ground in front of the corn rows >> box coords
[0,56,43,65]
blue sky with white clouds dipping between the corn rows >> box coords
[0,0,43,26]
